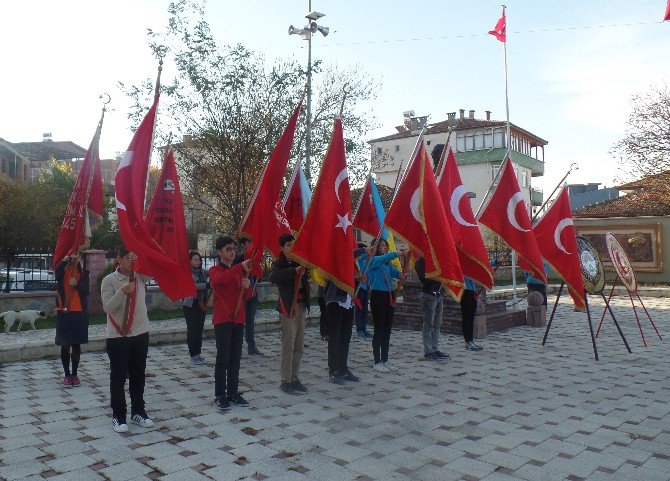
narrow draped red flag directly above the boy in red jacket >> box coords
[238,100,302,278]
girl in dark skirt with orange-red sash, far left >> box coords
[55,252,89,388]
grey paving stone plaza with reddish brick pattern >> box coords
[0,297,670,481]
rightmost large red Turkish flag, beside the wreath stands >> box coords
[533,189,585,309]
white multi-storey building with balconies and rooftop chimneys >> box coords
[369,109,547,211]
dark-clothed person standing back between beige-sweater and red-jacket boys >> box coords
[181,251,208,365]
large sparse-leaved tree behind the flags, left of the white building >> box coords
[121,0,377,232]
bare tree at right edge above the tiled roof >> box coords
[610,85,670,181]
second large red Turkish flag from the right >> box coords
[479,157,547,283]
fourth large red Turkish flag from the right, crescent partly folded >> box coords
[384,143,465,300]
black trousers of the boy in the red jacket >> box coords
[214,322,244,397]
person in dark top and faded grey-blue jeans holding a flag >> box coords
[414,257,448,361]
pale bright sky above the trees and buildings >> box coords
[0,0,670,193]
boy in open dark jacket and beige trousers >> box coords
[270,234,309,394]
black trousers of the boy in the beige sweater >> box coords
[106,332,149,419]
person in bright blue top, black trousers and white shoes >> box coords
[367,239,406,372]
